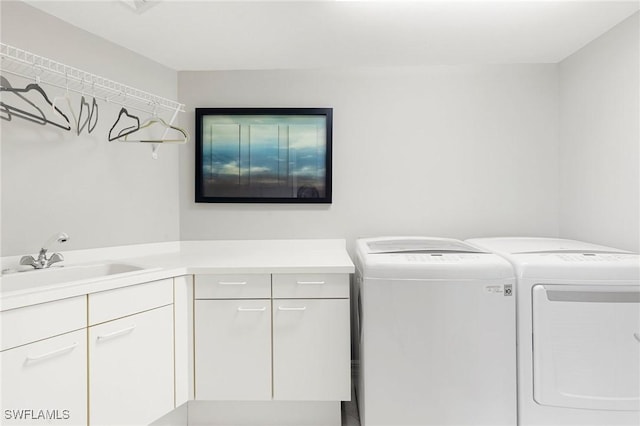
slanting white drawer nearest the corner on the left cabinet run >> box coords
[89,278,173,325]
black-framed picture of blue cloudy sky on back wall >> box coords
[195,108,333,203]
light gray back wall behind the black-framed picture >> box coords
[178,65,558,251]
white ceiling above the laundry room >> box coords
[22,0,640,70]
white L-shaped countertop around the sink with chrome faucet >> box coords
[0,239,354,311]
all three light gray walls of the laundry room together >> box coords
[0,1,640,256]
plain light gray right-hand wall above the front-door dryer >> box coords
[560,13,640,251]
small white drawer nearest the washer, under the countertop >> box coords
[273,274,349,299]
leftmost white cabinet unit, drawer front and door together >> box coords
[0,296,87,425]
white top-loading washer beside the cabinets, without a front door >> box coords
[356,237,516,426]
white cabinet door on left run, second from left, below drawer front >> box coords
[89,305,174,426]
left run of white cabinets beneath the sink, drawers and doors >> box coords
[0,279,174,426]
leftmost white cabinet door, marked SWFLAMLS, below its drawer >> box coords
[0,329,87,426]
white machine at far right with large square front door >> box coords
[467,238,640,426]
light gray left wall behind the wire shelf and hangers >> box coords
[0,1,179,256]
